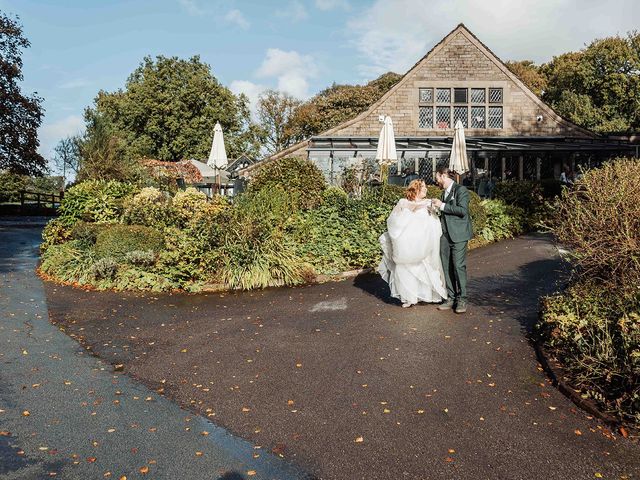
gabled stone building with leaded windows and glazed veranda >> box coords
[243,24,636,186]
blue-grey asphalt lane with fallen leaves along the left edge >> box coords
[0,223,308,480]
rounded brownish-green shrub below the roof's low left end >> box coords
[248,158,327,209]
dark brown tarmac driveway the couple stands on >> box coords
[40,230,640,480]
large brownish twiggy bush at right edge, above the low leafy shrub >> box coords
[553,159,640,295]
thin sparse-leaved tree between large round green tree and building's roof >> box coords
[258,90,302,154]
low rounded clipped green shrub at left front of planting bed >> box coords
[94,224,164,260]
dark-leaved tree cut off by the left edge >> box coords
[0,12,46,175]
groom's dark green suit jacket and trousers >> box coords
[440,182,473,302]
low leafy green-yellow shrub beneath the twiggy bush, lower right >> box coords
[537,280,640,426]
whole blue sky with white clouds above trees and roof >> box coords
[0,0,640,169]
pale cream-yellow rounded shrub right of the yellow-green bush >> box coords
[123,187,174,228]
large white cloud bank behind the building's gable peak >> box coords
[350,0,640,78]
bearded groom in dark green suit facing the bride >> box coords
[433,167,473,313]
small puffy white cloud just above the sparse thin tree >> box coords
[256,48,318,99]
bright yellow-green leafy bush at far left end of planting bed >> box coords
[60,180,136,222]
